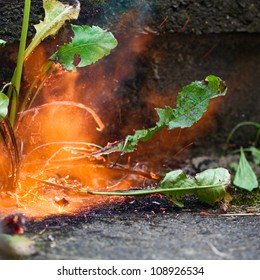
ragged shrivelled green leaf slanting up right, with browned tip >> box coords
[114,76,227,152]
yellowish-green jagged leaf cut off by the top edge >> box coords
[25,0,80,58]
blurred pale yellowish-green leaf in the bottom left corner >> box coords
[0,234,37,259]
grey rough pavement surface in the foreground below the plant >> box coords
[23,196,260,260]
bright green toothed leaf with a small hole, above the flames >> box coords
[50,25,117,71]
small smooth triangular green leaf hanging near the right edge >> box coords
[234,147,258,191]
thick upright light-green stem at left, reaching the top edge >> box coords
[10,0,31,126]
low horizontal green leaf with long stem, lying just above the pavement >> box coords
[86,168,231,207]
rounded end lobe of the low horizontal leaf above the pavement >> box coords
[195,168,231,205]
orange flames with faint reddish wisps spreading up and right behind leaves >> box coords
[0,11,223,218]
